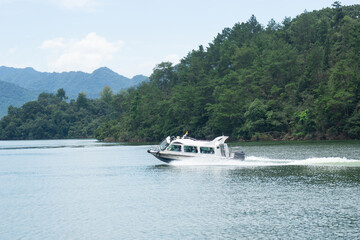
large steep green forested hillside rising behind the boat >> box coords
[96,2,360,141]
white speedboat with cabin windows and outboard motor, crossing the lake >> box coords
[148,132,245,163]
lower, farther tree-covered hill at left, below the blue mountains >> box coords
[0,87,112,140]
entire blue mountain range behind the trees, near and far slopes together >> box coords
[0,66,149,118]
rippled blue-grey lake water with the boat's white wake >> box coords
[0,140,360,239]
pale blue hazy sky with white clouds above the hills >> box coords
[0,0,359,77]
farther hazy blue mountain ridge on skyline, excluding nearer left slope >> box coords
[0,66,148,98]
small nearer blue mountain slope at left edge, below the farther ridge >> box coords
[0,81,39,118]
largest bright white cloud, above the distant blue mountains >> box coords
[41,33,123,72]
